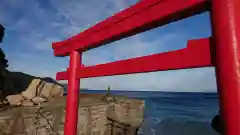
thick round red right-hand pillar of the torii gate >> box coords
[212,0,240,135]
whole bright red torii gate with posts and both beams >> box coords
[53,0,240,135]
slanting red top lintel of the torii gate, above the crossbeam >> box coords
[53,0,208,56]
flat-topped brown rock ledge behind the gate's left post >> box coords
[0,94,144,135]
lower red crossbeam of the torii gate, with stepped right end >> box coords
[57,38,212,80]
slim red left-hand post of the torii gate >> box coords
[64,51,81,135]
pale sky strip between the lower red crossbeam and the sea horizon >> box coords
[81,68,216,92]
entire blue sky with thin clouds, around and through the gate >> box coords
[0,0,216,92]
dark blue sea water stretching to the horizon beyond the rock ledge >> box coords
[78,90,218,135]
